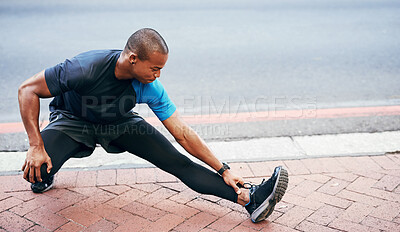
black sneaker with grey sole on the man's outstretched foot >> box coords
[244,166,289,223]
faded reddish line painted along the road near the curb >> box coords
[0,106,400,134]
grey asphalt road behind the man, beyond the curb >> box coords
[0,0,400,145]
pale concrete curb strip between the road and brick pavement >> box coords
[0,131,400,175]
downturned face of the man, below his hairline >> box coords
[131,52,168,84]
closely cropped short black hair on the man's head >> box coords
[124,28,169,60]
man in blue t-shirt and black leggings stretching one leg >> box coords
[18,28,288,222]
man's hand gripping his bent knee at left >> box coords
[22,145,53,183]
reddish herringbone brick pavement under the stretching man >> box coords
[0,154,400,232]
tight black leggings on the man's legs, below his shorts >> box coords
[41,120,237,203]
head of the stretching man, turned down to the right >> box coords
[123,28,168,84]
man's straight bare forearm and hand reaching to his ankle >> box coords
[162,111,244,194]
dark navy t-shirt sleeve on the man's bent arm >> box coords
[44,58,84,96]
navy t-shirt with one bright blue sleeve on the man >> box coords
[45,50,176,123]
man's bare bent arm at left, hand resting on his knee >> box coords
[18,71,52,183]
